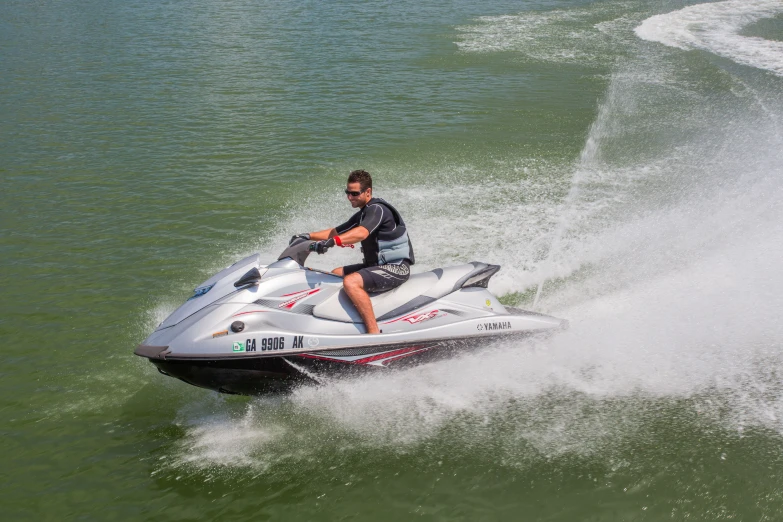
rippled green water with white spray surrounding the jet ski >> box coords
[0,0,783,521]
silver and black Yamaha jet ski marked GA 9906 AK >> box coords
[135,238,568,395]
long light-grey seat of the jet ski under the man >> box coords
[313,261,500,323]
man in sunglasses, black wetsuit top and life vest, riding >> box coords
[291,170,415,334]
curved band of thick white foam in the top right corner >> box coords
[635,0,783,76]
